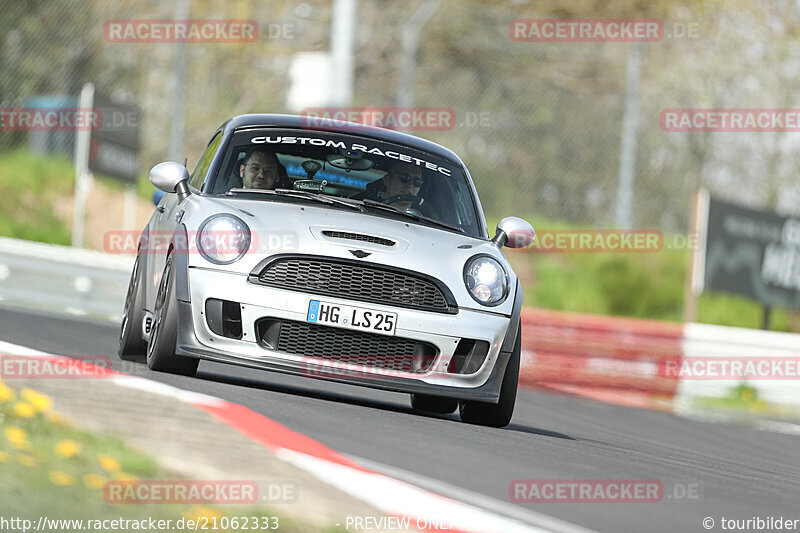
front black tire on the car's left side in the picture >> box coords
[147,256,200,376]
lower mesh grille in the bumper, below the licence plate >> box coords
[256,318,438,373]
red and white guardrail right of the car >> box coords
[520,309,800,411]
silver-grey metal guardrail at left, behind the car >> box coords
[0,237,134,321]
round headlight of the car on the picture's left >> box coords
[197,214,250,265]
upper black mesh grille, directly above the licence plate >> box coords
[258,257,455,313]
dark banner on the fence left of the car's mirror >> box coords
[89,97,139,183]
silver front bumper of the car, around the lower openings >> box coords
[176,268,521,403]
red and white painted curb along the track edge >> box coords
[0,341,591,533]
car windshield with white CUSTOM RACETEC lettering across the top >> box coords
[204,129,481,237]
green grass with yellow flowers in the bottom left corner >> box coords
[0,382,337,533]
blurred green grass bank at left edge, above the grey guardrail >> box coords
[0,150,75,244]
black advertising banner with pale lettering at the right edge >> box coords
[704,198,800,309]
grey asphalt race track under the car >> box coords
[0,309,800,532]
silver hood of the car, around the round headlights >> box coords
[183,196,517,315]
